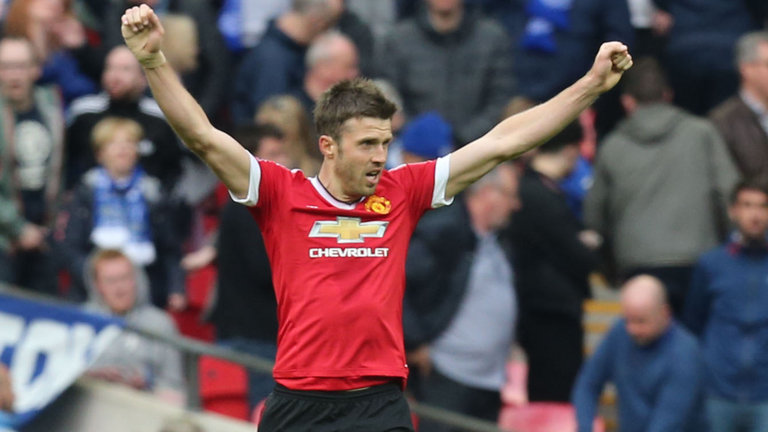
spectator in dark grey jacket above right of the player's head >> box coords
[380,0,513,144]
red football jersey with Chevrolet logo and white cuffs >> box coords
[233,157,450,390]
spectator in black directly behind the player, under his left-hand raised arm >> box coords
[210,125,295,407]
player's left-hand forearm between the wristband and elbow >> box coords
[144,62,213,154]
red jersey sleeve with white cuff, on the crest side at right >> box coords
[391,155,453,215]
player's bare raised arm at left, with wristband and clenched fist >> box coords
[121,5,250,197]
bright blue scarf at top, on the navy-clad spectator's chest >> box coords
[520,0,572,53]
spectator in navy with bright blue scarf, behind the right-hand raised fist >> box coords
[484,0,635,134]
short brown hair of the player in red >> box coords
[314,78,397,140]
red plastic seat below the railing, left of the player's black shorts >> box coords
[199,356,251,421]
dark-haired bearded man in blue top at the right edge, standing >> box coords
[683,181,768,432]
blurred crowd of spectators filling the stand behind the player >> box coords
[0,0,768,431]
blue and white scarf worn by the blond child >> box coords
[91,167,156,266]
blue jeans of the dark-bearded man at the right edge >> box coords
[706,397,768,432]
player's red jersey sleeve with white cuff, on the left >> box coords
[229,156,292,213]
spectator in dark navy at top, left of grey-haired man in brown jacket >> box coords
[654,0,764,115]
